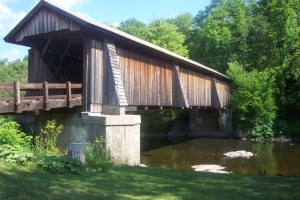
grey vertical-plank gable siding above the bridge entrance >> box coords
[15,8,79,42]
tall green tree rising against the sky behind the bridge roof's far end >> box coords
[189,0,255,73]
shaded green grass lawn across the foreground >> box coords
[0,164,300,200]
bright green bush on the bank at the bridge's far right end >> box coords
[227,63,277,138]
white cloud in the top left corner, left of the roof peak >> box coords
[0,0,26,37]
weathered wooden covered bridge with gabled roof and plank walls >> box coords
[0,1,231,164]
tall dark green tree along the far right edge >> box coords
[259,0,300,116]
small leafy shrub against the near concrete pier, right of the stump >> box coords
[85,137,114,171]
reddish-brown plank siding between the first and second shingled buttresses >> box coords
[117,48,173,106]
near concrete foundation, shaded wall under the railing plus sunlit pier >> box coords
[15,109,141,165]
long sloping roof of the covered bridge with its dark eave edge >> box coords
[4,0,231,82]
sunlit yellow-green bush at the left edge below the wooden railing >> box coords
[0,118,32,148]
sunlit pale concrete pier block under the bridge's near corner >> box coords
[81,113,141,165]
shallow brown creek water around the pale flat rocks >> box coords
[141,138,300,176]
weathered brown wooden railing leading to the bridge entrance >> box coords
[0,81,82,113]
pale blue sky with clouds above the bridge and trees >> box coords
[0,0,210,61]
